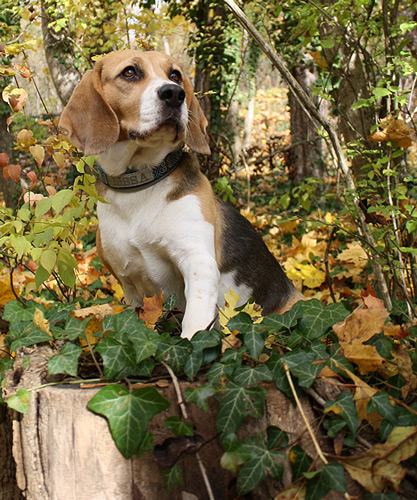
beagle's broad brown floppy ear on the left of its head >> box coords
[59,63,120,156]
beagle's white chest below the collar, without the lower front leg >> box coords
[97,183,215,307]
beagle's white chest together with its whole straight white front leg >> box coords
[97,177,219,338]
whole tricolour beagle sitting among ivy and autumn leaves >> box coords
[59,50,304,339]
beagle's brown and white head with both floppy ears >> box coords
[59,50,210,155]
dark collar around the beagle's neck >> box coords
[97,149,183,191]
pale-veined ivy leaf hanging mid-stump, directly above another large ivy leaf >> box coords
[215,382,266,433]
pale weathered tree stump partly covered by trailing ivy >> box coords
[4,347,346,500]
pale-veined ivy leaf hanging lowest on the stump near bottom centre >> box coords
[237,434,285,494]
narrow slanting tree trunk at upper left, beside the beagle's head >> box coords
[41,0,81,105]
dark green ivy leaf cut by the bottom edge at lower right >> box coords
[304,462,346,500]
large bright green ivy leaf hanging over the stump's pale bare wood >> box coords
[88,385,170,458]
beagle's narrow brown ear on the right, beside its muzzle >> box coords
[184,78,211,155]
